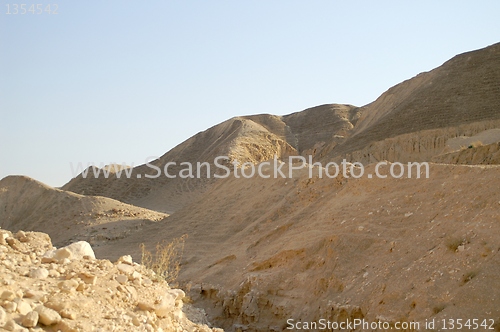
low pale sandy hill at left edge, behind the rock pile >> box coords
[0,176,168,246]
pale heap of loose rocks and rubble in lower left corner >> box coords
[0,229,222,332]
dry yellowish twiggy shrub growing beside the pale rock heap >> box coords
[140,234,187,283]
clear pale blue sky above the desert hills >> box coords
[0,0,500,187]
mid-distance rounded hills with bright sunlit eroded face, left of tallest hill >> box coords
[62,105,359,213]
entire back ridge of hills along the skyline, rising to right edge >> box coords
[63,44,500,213]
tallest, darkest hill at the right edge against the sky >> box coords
[321,43,500,162]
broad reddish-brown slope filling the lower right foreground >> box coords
[88,164,500,331]
